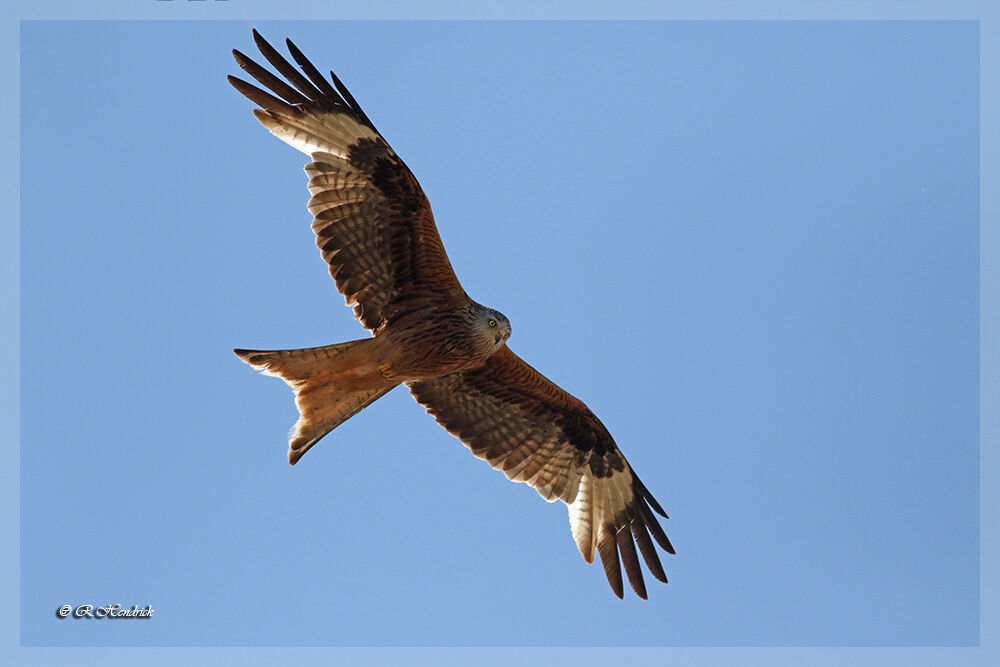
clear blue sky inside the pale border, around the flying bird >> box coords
[21,22,979,646]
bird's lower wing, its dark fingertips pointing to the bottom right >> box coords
[409,348,674,599]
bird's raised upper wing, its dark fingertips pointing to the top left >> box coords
[229,30,467,331]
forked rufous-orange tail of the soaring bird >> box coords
[233,338,396,465]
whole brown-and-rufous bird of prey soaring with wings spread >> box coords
[229,30,674,599]
